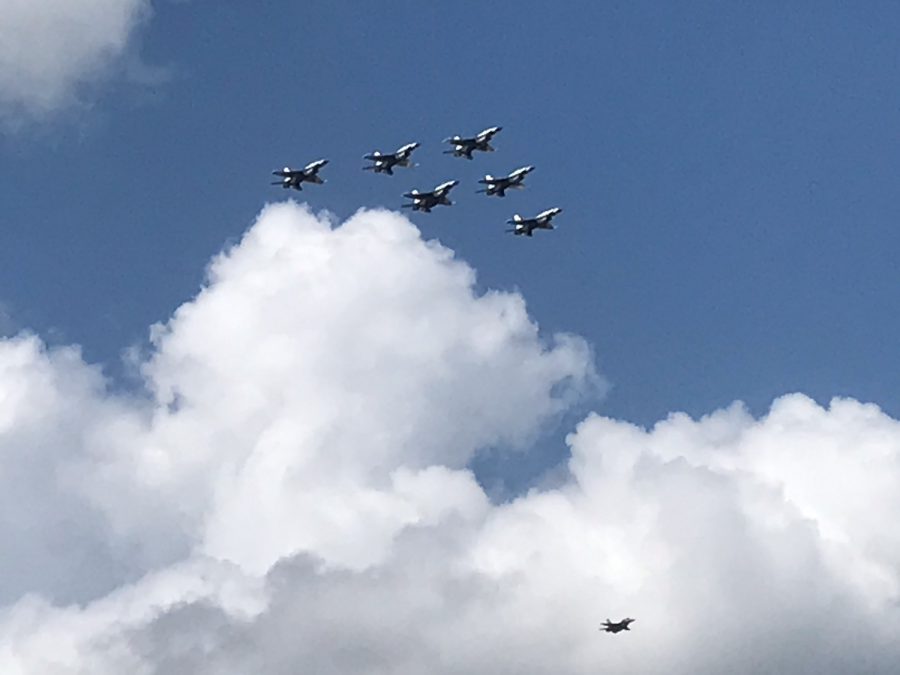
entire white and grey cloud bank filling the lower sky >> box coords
[0,204,900,675]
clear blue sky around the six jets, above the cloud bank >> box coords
[0,1,900,424]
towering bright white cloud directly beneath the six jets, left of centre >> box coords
[0,204,596,600]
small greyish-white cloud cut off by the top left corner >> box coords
[0,0,150,123]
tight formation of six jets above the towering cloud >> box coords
[272,127,562,237]
